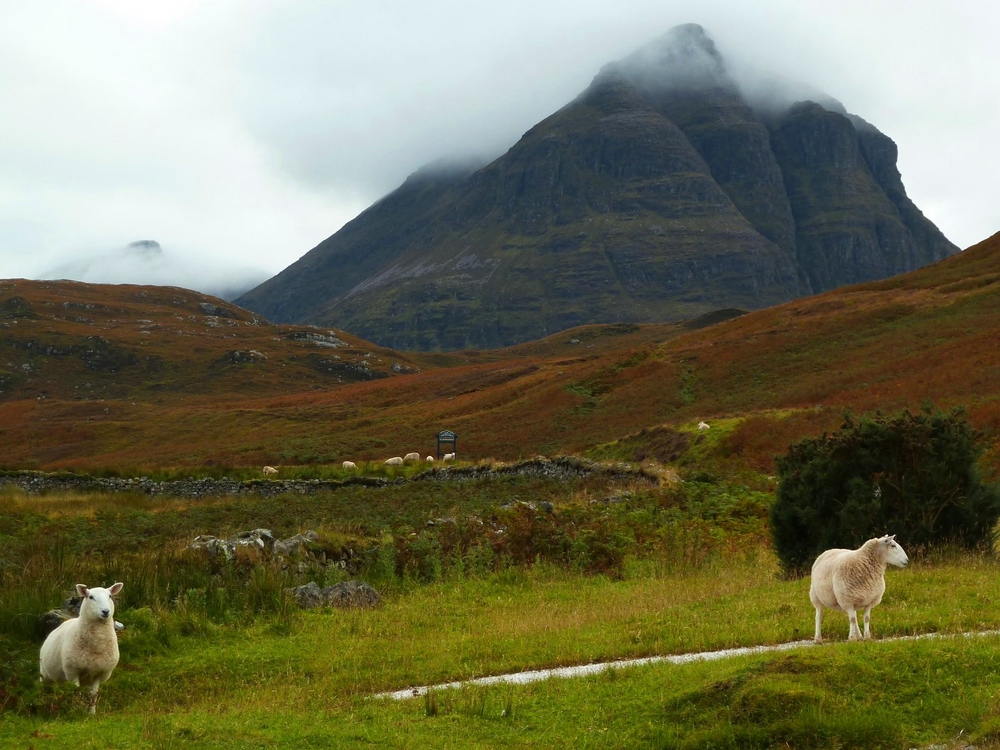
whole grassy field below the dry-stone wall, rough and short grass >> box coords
[0,468,1000,748]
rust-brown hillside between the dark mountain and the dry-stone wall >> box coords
[0,235,1000,468]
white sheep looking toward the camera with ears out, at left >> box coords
[39,583,125,714]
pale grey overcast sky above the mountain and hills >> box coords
[0,0,1000,300]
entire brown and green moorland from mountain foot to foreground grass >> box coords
[0,235,1000,748]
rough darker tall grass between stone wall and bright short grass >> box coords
[0,477,768,711]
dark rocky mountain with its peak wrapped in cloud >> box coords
[237,24,957,350]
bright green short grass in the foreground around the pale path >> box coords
[0,556,1000,748]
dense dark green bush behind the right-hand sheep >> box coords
[771,407,1000,574]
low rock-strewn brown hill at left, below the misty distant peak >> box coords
[0,279,415,403]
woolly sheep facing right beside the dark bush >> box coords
[809,534,909,643]
